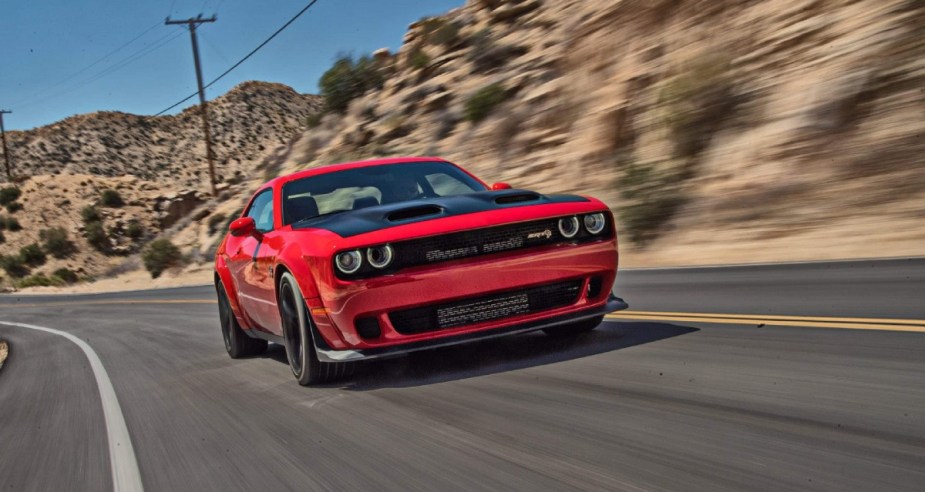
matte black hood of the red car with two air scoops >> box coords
[292,189,590,238]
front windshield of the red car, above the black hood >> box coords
[282,162,487,224]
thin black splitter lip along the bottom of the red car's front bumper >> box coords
[313,294,629,362]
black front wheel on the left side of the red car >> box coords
[278,272,354,386]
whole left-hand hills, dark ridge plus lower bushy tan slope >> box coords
[0,82,321,288]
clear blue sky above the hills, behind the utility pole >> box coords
[0,0,464,130]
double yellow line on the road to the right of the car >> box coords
[607,311,925,333]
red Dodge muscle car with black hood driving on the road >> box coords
[215,157,626,385]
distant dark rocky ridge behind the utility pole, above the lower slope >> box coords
[0,82,320,190]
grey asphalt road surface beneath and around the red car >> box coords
[0,260,925,491]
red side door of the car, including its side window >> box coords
[226,189,279,334]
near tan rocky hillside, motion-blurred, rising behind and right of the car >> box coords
[284,0,925,264]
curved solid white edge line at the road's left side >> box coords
[0,321,144,492]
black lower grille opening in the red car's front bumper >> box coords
[389,280,582,335]
